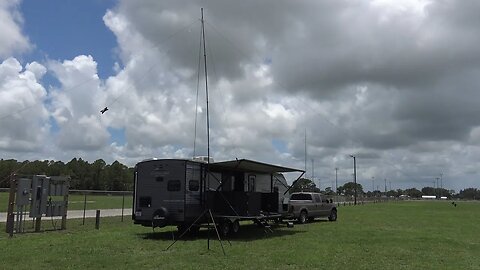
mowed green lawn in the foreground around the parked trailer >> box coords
[0,201,480,269]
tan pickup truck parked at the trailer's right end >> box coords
[286,192,337,224]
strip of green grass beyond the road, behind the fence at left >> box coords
[0,192,132,212]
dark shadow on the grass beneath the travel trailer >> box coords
[138,221,306,242]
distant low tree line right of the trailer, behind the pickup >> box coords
[290,178,480,200]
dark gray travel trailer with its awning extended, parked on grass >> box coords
[132,159,304,234]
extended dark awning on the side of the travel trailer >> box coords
[209,159,304,174]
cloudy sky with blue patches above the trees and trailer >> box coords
[0,0,480,192]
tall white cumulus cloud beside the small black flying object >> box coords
[49,55,110,151]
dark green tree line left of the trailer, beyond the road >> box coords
[0,158,134,190]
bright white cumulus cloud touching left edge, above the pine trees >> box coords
[0,58,49,152]
